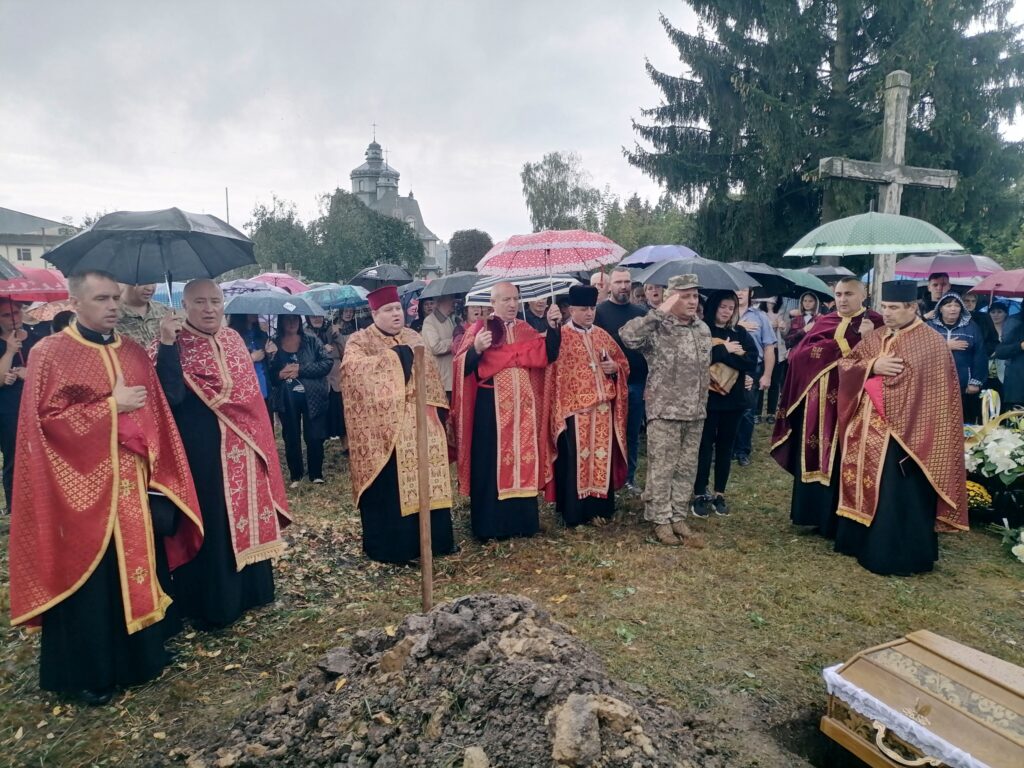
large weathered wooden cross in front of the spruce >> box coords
[818,70,958,290]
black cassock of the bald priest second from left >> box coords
[157,344,273,630]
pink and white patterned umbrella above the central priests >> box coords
[476,229,626,278]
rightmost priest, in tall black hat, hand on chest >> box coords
[836,281,968,575]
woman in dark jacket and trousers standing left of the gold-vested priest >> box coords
[269,314,333,488]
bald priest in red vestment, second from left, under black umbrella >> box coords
[157,280,292,630]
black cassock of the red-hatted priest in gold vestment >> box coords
[359,344,455,563]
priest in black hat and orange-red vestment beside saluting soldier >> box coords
[542,286,630,526]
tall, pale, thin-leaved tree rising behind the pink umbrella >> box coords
[520,152,601,231]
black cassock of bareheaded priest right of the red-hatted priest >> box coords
[465,333,562,541]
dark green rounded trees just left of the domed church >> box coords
[246,189,424,281]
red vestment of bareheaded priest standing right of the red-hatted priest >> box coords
[452,319,548,501]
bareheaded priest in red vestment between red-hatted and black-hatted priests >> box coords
[452,283,561,540]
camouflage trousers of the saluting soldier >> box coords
[643,419,705,525]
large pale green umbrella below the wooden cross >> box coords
[783,213,964,256]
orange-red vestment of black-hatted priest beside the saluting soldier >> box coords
[542,326,630,502]
